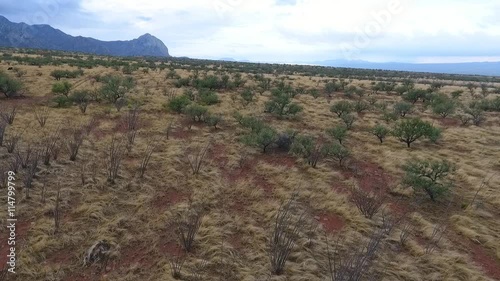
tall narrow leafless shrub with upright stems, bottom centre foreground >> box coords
[269,195,305,275]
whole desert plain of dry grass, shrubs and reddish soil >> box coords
[0,49,500,281]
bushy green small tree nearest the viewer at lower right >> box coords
[403,159,456,201]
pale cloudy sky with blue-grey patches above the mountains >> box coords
[0,0,500,62]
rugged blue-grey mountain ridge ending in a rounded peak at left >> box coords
[0,16,170,57]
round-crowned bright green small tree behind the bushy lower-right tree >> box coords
[392,118,432,147]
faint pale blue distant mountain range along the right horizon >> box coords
[311,60,500,76]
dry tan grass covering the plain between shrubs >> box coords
[0,53,500,281]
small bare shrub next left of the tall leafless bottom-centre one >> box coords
[174,203,203,252]
